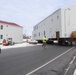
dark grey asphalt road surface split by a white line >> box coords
[0,45,76,75]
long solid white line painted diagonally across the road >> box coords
[26,47,74,75]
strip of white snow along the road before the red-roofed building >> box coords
[0,43,41,49]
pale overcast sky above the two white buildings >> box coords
[0,0,76,35]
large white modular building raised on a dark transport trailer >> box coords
[32,4,76,42]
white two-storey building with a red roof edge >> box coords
[0,21,23,43]
